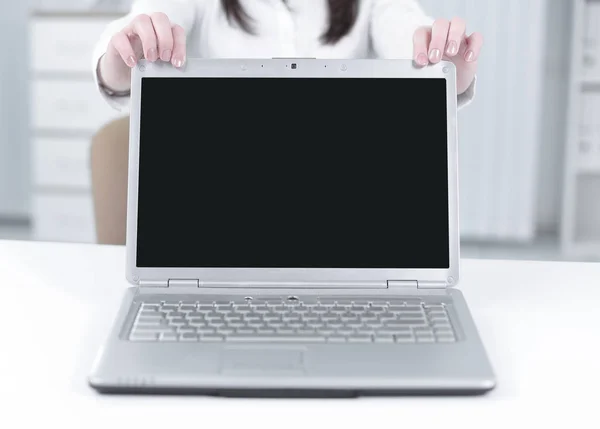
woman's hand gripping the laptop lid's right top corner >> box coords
[413,18,483,94]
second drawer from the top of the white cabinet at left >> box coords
[31,79,123,133]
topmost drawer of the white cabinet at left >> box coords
[31,15,117,75]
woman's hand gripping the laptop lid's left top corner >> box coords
[98,12,186,92]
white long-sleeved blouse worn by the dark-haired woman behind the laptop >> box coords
[93,0,475,111]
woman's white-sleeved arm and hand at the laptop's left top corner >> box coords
[92,0,196,110]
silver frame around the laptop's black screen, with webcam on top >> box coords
[126,58,460,286]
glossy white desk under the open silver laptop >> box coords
[0,241,600,429]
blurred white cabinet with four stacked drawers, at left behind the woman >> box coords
[30,12,122,243]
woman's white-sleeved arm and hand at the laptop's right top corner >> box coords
[371,0,483,107]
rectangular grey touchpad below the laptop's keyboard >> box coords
[221,346,305,375]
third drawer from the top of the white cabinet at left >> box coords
[33,138,91,189]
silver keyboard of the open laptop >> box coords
[129,297,457,343]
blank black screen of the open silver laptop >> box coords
[137,78,449,269]
